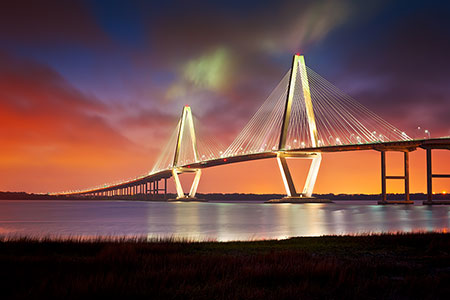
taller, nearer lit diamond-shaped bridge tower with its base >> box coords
[273,54,324,202]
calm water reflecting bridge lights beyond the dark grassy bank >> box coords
[0,201,450,241]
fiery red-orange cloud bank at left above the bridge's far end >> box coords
[0,53,151,191]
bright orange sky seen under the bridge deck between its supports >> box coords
[185,150,450,194]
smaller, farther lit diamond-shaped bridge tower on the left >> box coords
[172,105,202,200]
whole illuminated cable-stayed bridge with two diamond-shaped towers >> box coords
[61,54,450,204]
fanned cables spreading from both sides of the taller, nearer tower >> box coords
[222,64,410,157]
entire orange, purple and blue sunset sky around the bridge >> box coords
[0,0,450,193]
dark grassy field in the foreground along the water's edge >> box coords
[0,233,450,299]
